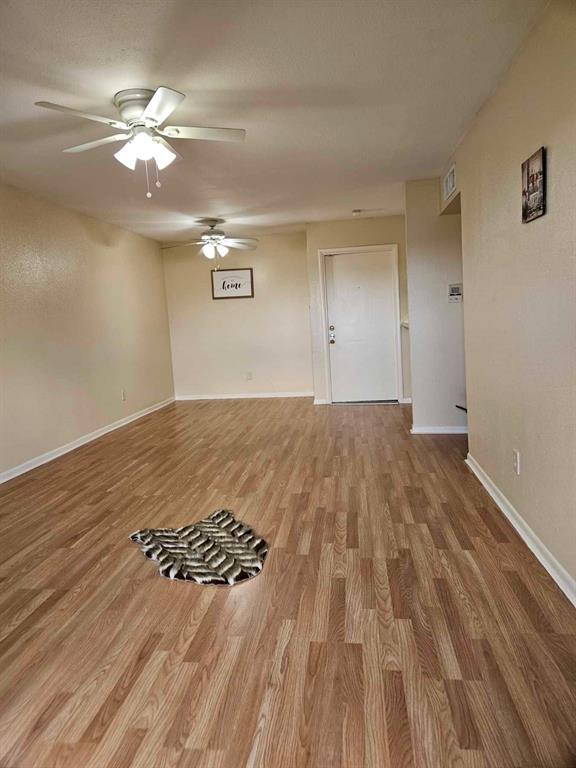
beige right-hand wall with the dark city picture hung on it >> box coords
[456,0,576,577]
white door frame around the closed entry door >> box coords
[318,243,404,404]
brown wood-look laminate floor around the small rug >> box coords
[0,399,576,768]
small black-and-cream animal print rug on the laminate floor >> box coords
[130,509,268,585]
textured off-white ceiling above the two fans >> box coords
[0,0,545,240]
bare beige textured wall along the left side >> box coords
[0,186,172,472]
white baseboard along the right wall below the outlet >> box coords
[466,454,576,606]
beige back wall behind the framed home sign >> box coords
[164,232,312,397]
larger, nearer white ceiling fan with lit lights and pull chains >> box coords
[36,86,246,197]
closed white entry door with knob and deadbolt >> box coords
[325,248,400,402]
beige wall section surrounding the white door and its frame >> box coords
[307,216,410,400]
